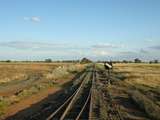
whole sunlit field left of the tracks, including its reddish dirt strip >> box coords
[0,63,83,118]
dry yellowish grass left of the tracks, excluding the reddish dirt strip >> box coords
[0,63,84,116]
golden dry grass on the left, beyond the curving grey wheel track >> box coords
[0,63,59,84]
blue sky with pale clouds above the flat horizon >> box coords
[0,0,160,60]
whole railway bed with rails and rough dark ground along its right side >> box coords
[30,64,123,120]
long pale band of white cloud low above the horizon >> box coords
[0,41,160,59]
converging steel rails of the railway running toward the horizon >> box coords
[46,69,93,120]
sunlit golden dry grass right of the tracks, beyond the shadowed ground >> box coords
[115,64,160,87]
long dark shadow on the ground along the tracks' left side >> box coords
[5,71,85,120]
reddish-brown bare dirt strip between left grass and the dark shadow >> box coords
[3,76,73,119]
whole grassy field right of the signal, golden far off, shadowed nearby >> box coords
[108,63,160,120]
